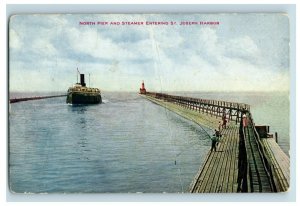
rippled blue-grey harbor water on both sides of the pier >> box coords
[9,93,289,193]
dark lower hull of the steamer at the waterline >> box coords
[66,92,102,104]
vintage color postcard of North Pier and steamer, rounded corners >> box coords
[8,13,290,193]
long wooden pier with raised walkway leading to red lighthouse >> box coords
[143,92,290,193]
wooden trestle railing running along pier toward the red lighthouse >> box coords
[146,92,250,123]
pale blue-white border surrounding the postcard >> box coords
[0,0,299,205]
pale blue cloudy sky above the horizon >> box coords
[9,13,290,92]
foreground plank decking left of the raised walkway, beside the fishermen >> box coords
[190,123,239,193]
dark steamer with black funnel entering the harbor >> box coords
[66,72,102,104]
